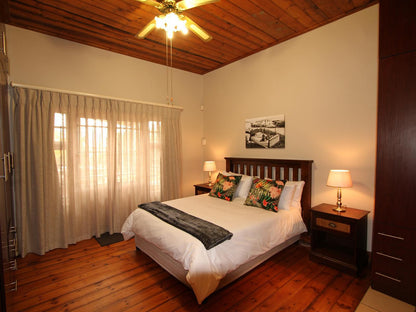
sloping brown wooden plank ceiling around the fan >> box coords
[0,0,378,74]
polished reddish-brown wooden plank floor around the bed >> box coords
[11,239,370,312]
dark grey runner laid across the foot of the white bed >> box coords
[139,201,233,250]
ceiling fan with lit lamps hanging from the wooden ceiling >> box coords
[136,0,219,41]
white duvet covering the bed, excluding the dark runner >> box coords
[122,194,306,303]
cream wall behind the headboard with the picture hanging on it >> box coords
[204,5,378,249]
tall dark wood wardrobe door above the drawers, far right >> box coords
[376,51,416,229]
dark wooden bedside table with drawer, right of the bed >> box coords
[310,204,369,275]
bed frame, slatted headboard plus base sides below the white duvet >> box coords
[135,157,313,302]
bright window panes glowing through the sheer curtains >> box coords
[54,113,161,201]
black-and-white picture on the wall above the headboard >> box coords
[245,115,285,148]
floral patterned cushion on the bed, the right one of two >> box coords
[244,178,286,212]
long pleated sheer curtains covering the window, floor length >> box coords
[11,87,181,256]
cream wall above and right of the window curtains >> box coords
[6,25,203,195]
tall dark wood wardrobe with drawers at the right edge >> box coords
[372,0,416,305]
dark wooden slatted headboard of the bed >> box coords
[224,157,313,229]
